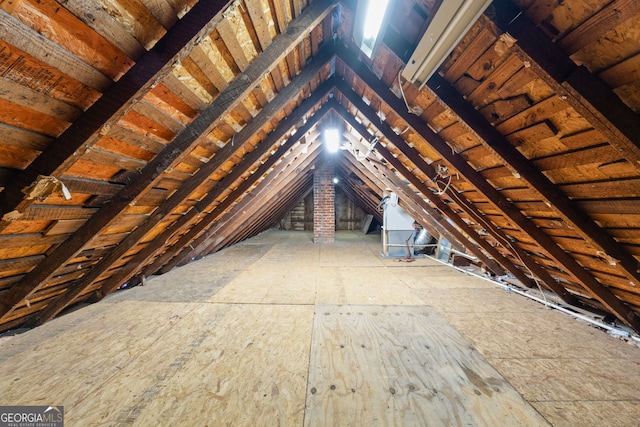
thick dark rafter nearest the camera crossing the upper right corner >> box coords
[493,1,640,170]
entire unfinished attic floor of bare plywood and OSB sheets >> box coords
[0,231,640,426]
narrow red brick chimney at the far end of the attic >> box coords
[313,162,336,243]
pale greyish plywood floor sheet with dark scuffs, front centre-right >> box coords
[305,306,547,426]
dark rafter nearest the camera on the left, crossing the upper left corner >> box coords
[0,0,228,226]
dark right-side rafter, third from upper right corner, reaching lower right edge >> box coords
[338,47,640,331]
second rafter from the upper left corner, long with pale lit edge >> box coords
[0,4,334,321]
